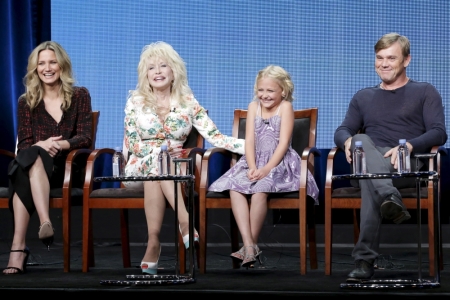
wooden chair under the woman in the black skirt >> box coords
[0,111,100,272]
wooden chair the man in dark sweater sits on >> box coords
[325,146,446,276]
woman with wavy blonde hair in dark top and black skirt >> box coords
[3,41,92,275]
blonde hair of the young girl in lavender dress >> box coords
[253,65,294,102]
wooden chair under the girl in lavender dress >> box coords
[199,108,320,274]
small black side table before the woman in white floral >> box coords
[94,158,195,286]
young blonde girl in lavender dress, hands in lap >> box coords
[209,65,319,267]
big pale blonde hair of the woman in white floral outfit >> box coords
[130,41,192,111]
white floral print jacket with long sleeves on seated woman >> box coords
[125,95,245,176]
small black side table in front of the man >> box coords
[331,171,441,289]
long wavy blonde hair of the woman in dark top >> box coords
[22,41,75,111]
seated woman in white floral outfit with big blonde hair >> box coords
[124,42,244,275]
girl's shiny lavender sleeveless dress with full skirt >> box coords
[208,104,319,204]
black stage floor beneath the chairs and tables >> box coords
[0,239,450,299]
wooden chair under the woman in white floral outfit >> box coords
[82,127,205,273]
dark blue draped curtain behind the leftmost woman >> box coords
[0,0,51,185]
